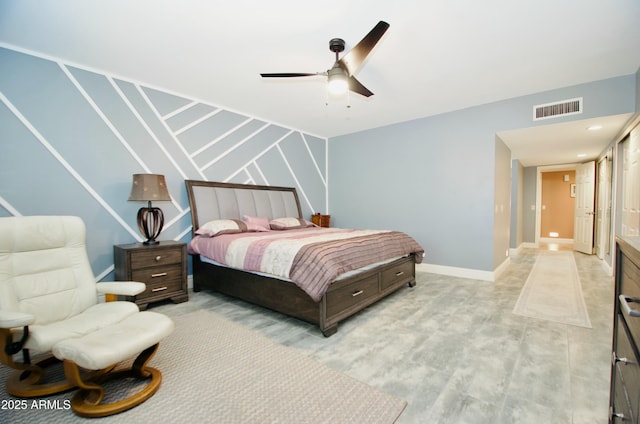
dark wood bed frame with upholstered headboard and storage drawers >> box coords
[185,180,416,337]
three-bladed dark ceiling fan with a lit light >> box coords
[260,21,389,97]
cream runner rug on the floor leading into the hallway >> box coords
[513,251,591,328]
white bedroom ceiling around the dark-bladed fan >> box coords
[0,0,640,165]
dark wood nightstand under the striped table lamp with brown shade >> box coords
[113,241,189,310]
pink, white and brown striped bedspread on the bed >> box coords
[189,227,424,302]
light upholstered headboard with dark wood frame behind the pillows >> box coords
[185,180,302,232]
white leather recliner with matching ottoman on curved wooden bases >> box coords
[0,216,173,416]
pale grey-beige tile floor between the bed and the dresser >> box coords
[152,249,613,424]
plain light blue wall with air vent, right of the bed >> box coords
[329,75,636,272]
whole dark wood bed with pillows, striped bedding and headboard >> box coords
[185,180,424,337]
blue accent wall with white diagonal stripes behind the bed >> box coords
[0,47,327,280]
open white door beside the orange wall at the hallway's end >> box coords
[573,161,596,255]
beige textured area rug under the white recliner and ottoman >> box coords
[0,310,406,424]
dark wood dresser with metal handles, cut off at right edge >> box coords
[609,237,640,424]
